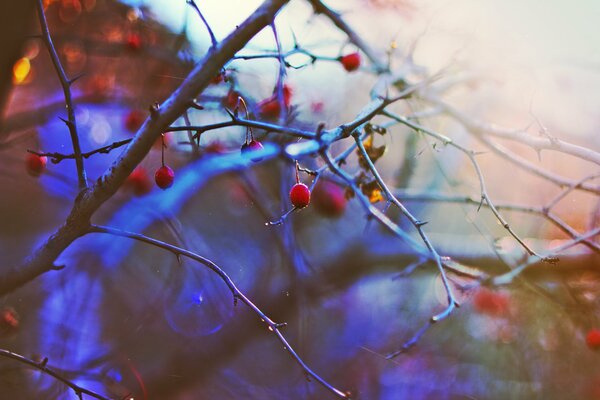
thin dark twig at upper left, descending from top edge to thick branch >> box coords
[37,0,87,189]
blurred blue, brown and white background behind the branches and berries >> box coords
[0,0,600,400]
